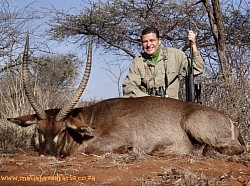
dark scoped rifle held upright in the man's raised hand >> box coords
[186,23,201,103]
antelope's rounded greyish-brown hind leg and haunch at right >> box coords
[182,107,245,156]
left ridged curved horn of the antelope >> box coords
[22,33,47,119]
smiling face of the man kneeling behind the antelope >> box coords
[142,33,161,55]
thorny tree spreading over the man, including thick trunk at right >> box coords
[47,0,249,85]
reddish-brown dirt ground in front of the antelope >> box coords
[0,149,250,186]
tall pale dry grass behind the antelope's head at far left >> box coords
[0,77,66,152]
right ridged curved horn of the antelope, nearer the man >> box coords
[56,35,92,121]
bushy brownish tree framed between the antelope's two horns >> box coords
[31,53,83,91]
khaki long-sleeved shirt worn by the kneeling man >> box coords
[123,47,204,99]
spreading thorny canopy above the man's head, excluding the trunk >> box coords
[47,0,208,57]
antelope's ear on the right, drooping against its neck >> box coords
[65,117,95,136]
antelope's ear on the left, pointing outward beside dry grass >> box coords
[7,114,38,127]
